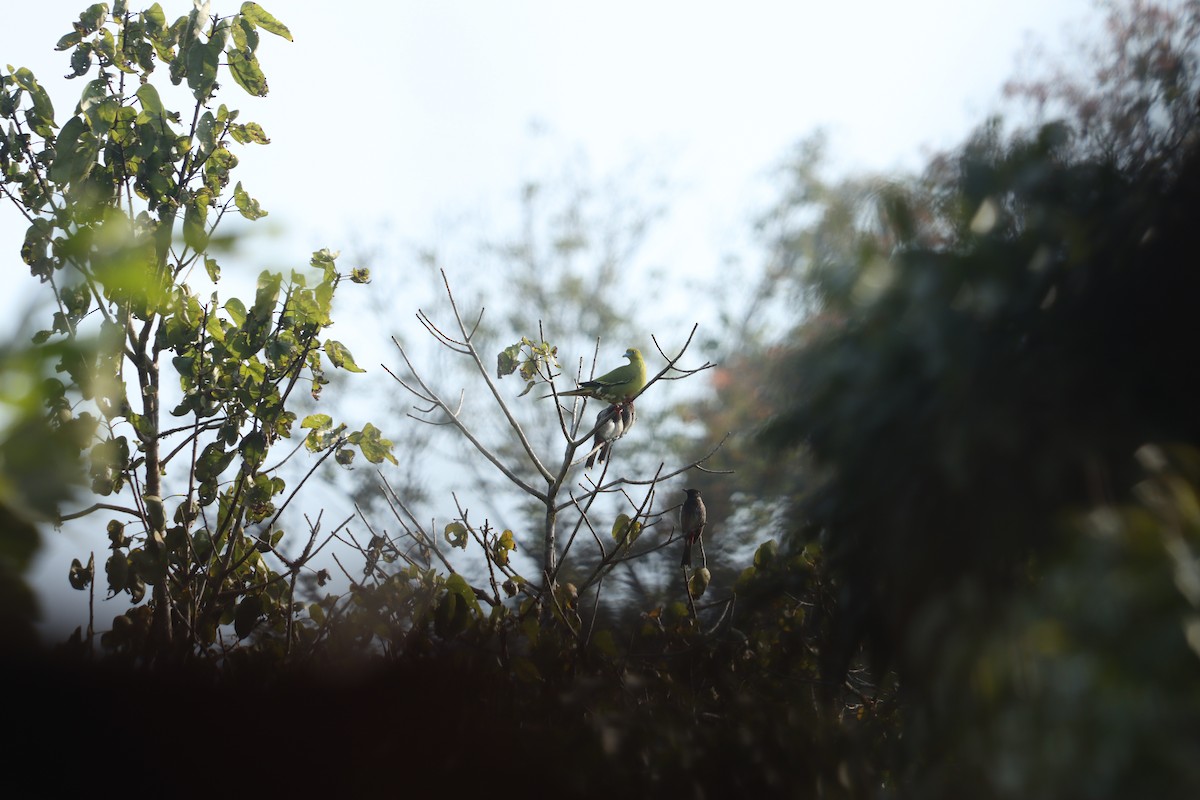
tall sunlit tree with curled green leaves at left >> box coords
[0,2,391,656]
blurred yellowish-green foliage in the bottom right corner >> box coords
[905,445,1200,798]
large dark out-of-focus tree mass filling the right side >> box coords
[753,4,1200,796]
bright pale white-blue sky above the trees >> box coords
[0,0,1097,627]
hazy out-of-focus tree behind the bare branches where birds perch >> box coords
[355,161,721,613]
